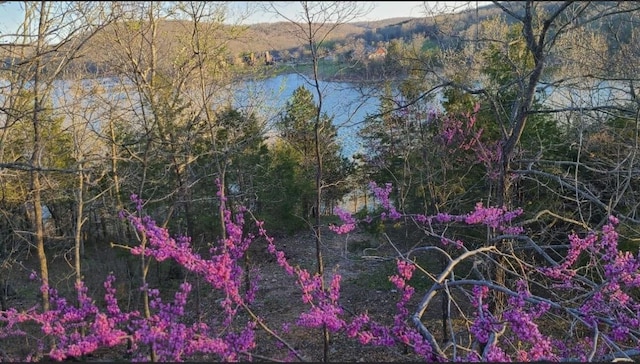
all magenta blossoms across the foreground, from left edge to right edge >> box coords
[0,179,640,361]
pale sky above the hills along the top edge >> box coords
[0,1,487,39]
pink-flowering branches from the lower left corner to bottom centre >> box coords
[0,182,440,361]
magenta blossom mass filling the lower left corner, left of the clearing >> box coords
[0,195,257,361]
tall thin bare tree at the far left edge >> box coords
[3,2,112,311]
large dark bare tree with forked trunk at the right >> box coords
[370,1,640,356]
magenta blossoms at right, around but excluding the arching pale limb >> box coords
[332,184,640,361]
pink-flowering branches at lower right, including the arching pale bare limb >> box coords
[330,183,640,361]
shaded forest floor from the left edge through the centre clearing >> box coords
[0,223,452,362]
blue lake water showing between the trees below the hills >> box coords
[7,74,629,161]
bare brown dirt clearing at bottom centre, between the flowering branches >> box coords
[245,229,436,362]
